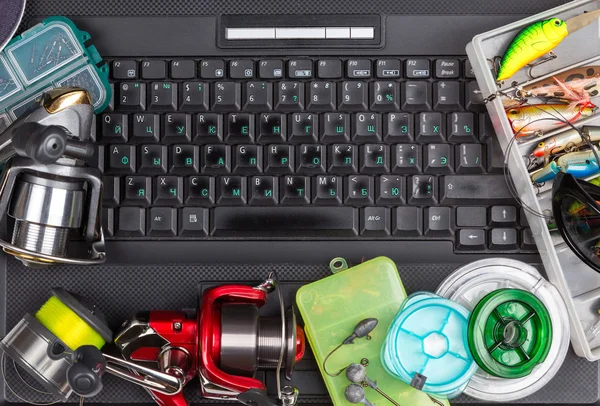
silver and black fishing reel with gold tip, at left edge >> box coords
[0,88,106,267]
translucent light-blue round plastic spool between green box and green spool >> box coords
[381,293,477,398]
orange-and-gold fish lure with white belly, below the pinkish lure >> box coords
[506,103,598,137]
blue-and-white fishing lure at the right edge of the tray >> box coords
[531,149,600,183]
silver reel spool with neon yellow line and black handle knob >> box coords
[0,288,112,402]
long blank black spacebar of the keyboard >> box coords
[211,207,358,238]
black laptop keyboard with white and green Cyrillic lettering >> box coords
[97,57,535,252]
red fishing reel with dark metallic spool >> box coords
[107,274,305,406]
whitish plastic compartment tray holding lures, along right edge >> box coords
[467,0,600,361]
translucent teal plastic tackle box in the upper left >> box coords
[0,16,112,132]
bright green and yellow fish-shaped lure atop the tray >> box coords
[496,18,569,82]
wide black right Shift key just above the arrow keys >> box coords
[441,175,515,205]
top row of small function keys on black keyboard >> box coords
[112,58,475,80]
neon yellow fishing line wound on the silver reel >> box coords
[35,296,106,351]
